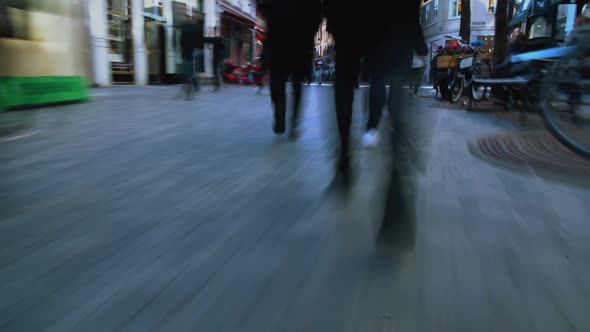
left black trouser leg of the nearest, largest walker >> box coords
[334,45,362,160]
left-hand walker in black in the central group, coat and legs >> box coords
[258,0,322,138]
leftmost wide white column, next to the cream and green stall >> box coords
[87,1,112,86]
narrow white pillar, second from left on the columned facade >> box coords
[131,0,149,85]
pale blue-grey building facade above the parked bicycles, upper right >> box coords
[420,0,497,81]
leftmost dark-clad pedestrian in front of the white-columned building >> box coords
[180,16,204,100]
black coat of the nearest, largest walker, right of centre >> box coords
[323,0,428,73]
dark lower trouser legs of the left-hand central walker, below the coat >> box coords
[270,71,304,129]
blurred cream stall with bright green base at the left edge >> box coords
[0,0,91,109]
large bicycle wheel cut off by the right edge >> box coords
[541,51,590,158]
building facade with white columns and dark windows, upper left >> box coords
[86,0,256,86]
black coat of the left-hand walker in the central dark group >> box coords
[258,0,322,74]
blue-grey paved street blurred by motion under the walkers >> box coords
[0,86,590,332]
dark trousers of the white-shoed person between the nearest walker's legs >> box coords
[367,73,403,130]
